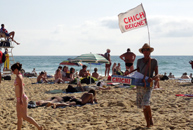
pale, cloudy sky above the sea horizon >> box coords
[0,0,193,56]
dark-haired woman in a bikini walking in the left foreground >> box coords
[11,63,42,130]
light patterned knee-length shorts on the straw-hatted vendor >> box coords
[136,86,152,108]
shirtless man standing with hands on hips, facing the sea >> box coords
[120,48,136,71]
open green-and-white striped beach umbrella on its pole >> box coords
[71,53,109,83]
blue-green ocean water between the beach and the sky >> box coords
[14,56,193,77]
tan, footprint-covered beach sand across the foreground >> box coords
[0,75,193,130]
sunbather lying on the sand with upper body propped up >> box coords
[46,89,97,108]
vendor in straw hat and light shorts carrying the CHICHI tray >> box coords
[137,43,158,128]
